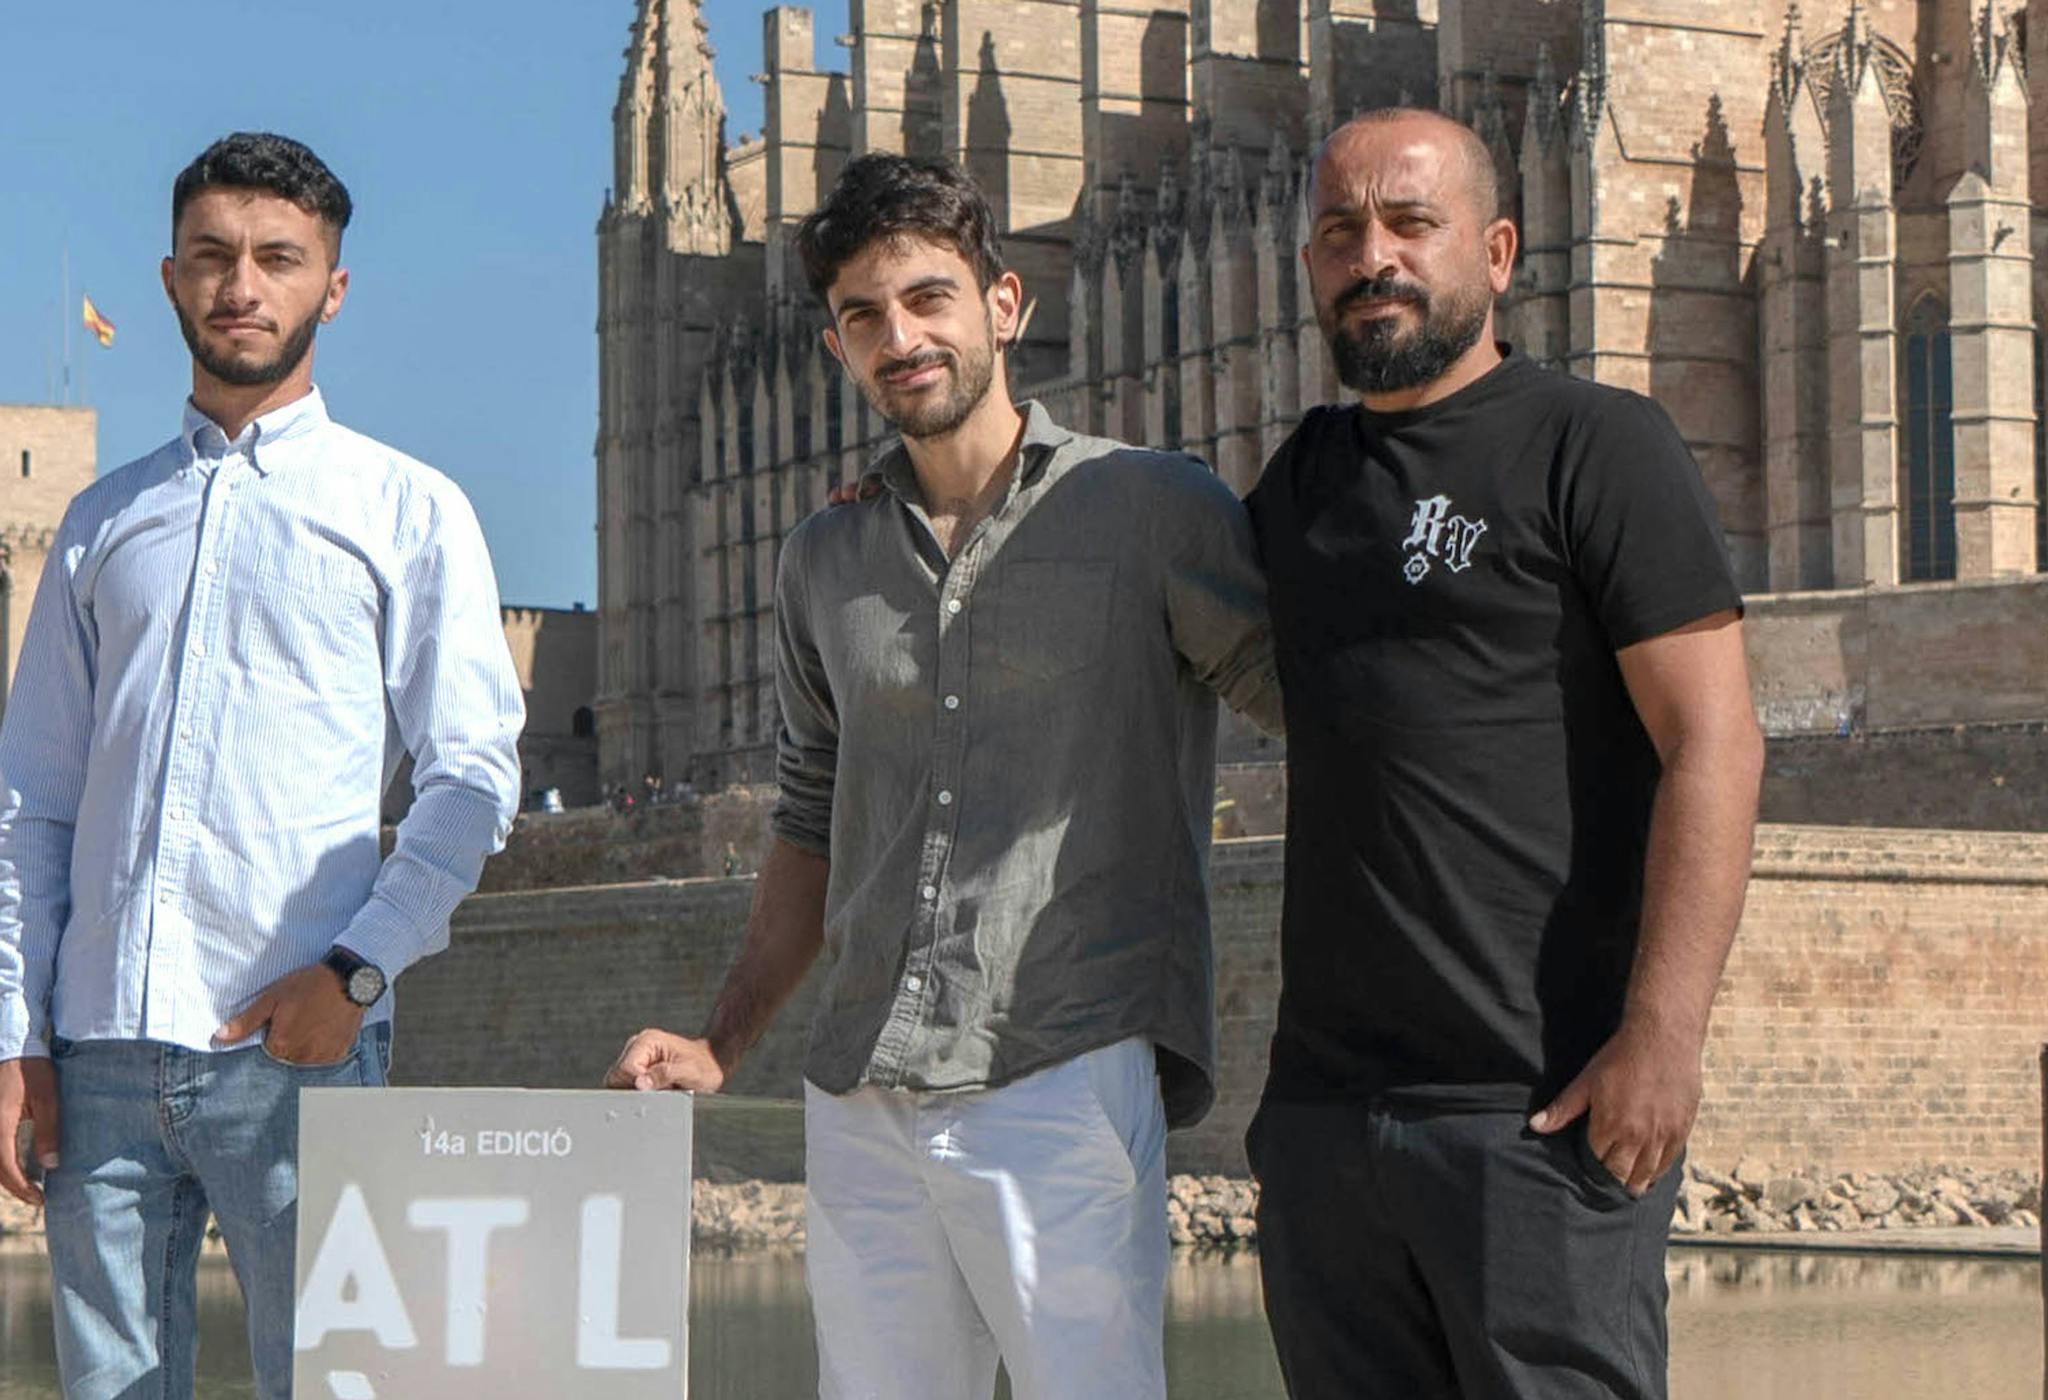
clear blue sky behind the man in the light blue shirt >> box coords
[0,0,846,606]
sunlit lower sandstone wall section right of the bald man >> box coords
[1694,827,2048,1171]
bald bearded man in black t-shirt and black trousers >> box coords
[1245,111,1761,1400]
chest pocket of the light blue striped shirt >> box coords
[238,546,383,696]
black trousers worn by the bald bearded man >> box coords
[1245,1101,1681,1400]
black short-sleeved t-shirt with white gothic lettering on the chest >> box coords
[1247,350,1741,1109]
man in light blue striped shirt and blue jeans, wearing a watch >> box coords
[0,133,522,1400]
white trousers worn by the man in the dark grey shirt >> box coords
[803,1040,1167,1400]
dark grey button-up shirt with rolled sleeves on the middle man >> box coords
[774,403,1280,1126]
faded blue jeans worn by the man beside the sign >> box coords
[45,1023,391,1400]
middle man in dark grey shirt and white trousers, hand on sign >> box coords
[608,156,1278,1400]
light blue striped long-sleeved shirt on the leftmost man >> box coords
[0,391,524,1060]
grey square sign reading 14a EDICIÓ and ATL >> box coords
[293,1089,690,1400]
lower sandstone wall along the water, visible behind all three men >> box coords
[395,827,2048,1175]
